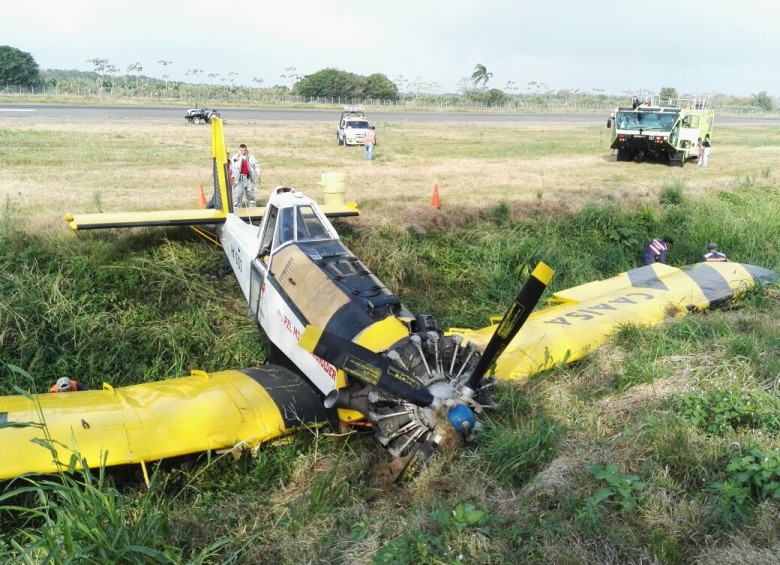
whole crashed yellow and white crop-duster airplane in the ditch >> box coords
[0,119,777,480]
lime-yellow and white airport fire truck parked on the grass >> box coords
[607,97,715,167]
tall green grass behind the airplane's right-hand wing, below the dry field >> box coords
[352,176,780,326]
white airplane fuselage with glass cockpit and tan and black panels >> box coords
[220,189,410,404]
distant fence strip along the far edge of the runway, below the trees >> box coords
[0,85,780,118]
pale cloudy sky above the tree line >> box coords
[0,0,780,97]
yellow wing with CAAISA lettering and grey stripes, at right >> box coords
[449,263,778,379]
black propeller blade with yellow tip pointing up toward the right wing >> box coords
[468,262,555,390]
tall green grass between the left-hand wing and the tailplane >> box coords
[0,222,264,394]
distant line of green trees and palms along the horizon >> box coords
[0,45,777,112]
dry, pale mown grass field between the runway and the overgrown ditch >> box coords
[0,120,780,231]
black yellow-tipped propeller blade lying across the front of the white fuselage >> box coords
[298,325,433,406]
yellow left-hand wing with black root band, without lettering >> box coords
[0,365,326,479]
